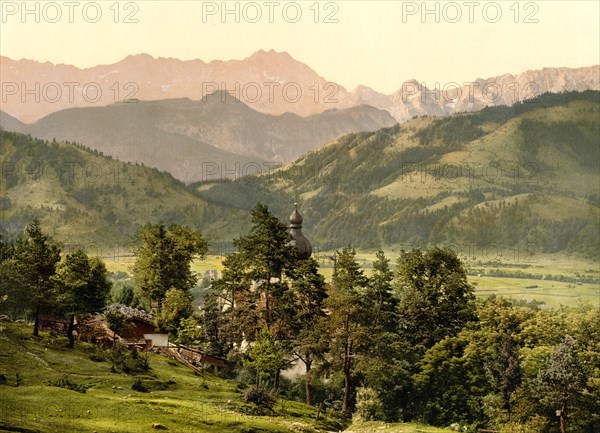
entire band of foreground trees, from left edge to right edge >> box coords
[0,208,600,433]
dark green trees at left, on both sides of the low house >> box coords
[0,219,207,347]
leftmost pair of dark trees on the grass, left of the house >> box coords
[0,219,111,347]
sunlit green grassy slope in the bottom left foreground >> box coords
[0,323,343,433]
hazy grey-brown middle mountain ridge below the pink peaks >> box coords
[0,91,395,183]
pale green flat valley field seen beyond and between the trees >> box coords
[104,251,600,308]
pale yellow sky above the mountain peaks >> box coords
[0,0,600,93]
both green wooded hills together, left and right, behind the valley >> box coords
[0,91,600,256]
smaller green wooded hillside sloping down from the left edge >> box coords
[0,130,248,250]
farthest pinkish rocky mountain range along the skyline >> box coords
[0,50,600,123]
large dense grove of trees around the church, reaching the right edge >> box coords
[149,205,600,432]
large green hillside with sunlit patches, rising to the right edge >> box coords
[195,91,600,257]
